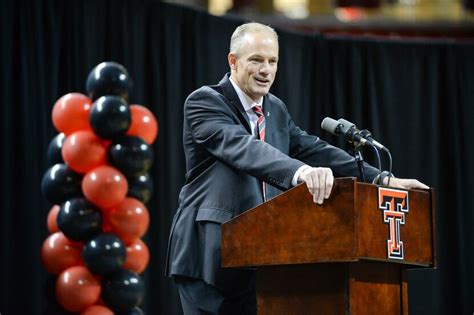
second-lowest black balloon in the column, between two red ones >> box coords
[82,233,126,275]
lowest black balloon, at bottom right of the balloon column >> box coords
[102,270,145,314]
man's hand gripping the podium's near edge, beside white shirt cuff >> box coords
[298,167,334,205]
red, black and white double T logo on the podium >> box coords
[379,187,408,260]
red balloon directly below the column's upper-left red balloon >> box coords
[61,130,107,173]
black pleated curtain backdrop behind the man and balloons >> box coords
[0,0,474,315]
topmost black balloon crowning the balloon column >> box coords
[86,61,132,101]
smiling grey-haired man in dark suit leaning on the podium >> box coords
[167,23,428,314]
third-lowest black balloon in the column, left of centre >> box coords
[57,198,102,241]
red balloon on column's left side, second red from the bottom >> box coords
[41,232,84,274]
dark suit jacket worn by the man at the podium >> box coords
[166,74,378,288]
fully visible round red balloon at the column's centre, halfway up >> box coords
[82,165,128,209]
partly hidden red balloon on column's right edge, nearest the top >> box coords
[127,104,158,144]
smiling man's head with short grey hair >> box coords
[227,23,278,101]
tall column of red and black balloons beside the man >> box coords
[41,62,158,314]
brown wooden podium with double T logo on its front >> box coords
[222,178,436,315]
